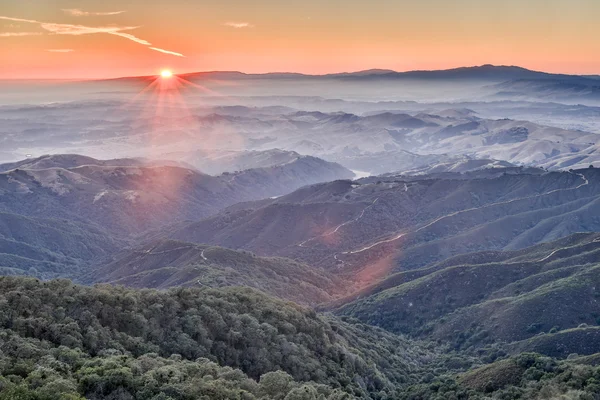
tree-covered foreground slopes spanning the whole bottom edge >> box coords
[0,277,600,400]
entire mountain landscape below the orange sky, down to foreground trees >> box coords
[0,61,600,400]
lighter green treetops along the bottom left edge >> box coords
[0,346,351,400]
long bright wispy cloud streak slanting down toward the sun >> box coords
[0,16,184,57]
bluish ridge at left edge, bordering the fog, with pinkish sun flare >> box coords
[0,154,353,278]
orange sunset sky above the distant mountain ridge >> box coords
[0,0,600,79]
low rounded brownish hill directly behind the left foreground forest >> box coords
[81,240,344,304]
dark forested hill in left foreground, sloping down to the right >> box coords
[0,277,433,399]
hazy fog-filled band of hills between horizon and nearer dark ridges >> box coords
[0,66,600,175]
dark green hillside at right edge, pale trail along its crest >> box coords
[332,233,600,357]
